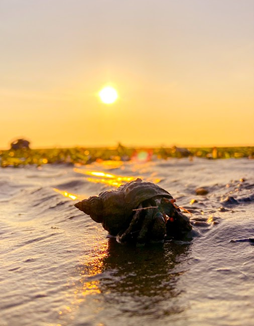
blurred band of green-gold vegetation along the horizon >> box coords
[0,144,254,167]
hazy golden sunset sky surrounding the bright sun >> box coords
[0,0,254,148]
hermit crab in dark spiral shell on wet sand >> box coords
[75,178,191,244]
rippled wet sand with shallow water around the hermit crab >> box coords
[0,159,254,326]
